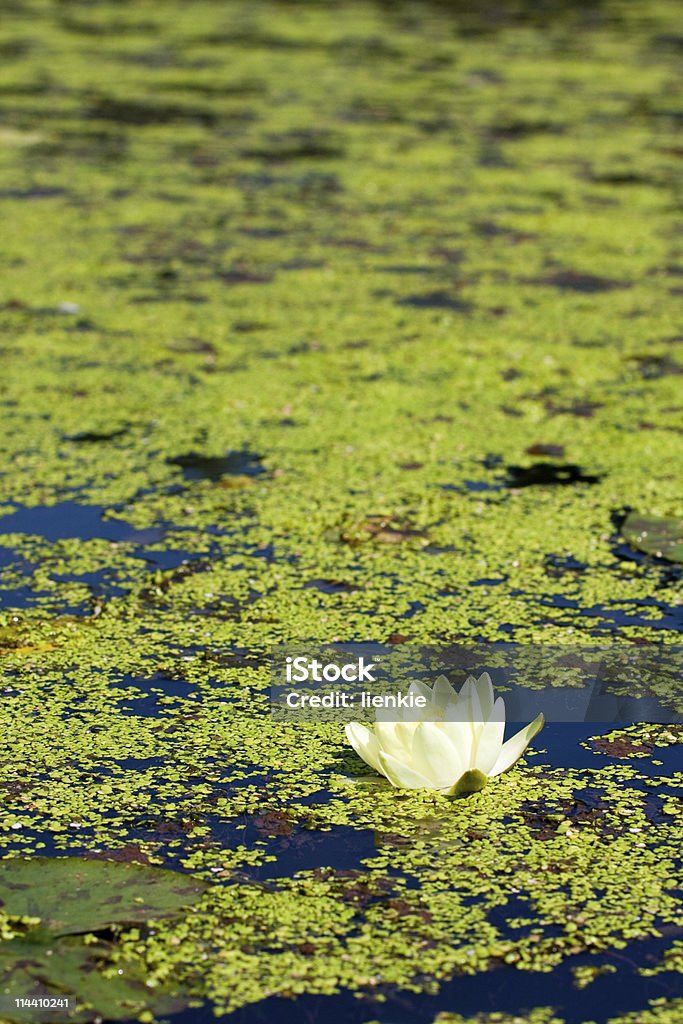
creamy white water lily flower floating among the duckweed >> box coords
[346,672,544,797]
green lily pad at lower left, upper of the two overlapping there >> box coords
[0,857,206,935]
